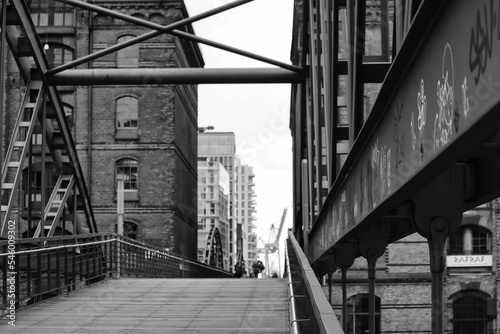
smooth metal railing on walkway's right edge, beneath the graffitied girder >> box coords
[285,232,344,334]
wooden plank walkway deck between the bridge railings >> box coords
[0,278,290,334]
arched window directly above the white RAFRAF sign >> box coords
[448,225,491,255]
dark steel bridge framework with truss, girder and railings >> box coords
[0,0,500,334]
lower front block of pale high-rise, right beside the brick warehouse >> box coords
[198,158,230,270]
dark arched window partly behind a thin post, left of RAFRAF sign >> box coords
[347,293,380,334]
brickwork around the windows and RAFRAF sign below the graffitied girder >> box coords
[324,204,500,333]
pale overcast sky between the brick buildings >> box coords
[184,0,293,266]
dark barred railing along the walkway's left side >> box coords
[0,233,234,315]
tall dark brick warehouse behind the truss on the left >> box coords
[6,0,204,259]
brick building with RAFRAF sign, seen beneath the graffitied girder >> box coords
[324,200,500,333]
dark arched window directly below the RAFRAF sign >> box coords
[451,290,490,334]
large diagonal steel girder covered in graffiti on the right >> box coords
[311,0,500,256]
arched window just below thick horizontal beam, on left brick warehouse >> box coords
[115,96,139,140]
